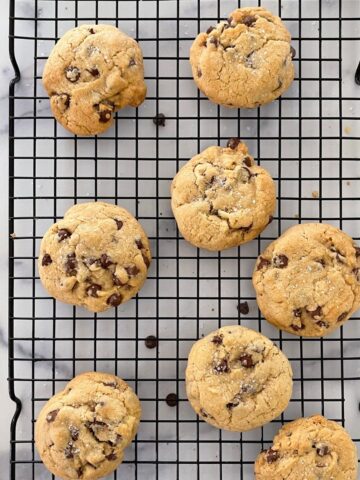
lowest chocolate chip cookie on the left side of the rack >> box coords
[35,372,141,480]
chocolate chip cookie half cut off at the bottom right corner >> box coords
[255,415,358,480]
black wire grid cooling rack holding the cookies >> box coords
[9,0,360,480]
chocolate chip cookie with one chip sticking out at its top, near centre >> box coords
[171,138,276,250]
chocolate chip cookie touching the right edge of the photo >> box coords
[253,223,360,337]
